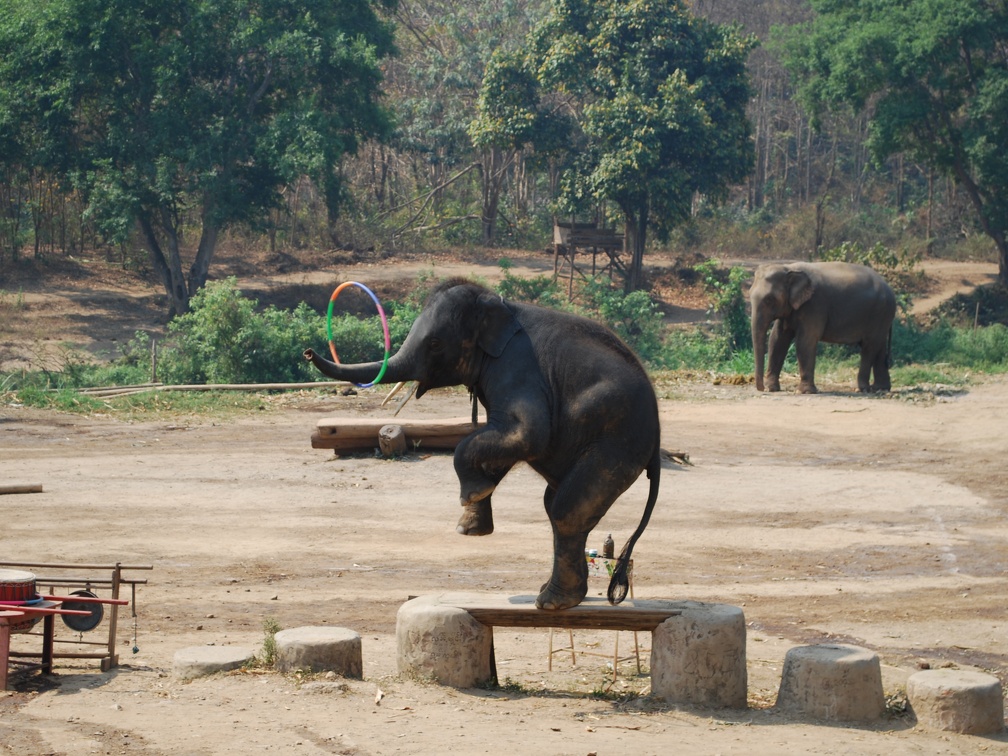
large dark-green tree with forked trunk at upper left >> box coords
[0,0,394,314]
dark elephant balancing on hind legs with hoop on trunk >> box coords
[304,279,661,609]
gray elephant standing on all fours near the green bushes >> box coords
[749,262,896,394]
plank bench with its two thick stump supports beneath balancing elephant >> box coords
[396,594,747,708]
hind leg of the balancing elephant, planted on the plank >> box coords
[535,443,641,609]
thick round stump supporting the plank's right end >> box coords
[651,601,748,709]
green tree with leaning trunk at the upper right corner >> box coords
[783,0,1008,285]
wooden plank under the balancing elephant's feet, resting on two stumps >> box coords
[413,594,682,632]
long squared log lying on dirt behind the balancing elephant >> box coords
[311,417,484,452]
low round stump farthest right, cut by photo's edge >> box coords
[906,669,1005,735]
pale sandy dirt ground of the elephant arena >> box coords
[0,252,1008,756]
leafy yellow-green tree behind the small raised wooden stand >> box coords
[531,0,754,290]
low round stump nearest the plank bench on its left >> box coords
[274,627,364,679]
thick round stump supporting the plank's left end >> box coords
[395,596,494,687]
